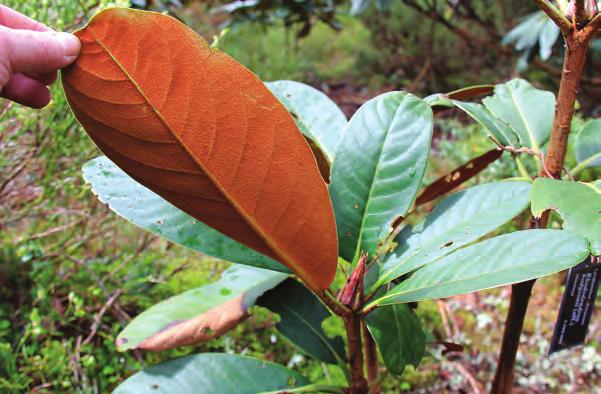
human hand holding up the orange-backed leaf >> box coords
[0,4,81,108]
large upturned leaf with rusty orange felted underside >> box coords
[63,8,338,291]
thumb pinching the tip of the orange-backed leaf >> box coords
[0,26,81,75]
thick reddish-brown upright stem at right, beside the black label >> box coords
[491,14,594,394]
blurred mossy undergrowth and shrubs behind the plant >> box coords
[0,0,601,393]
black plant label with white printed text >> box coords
[549,256,601,354]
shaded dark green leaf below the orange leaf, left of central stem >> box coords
[257,279,345,364]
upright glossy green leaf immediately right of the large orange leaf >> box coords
[330,92,433,261]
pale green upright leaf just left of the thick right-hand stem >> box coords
[482,79,555,150]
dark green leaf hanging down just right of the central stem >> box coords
[365,304,426,375]
